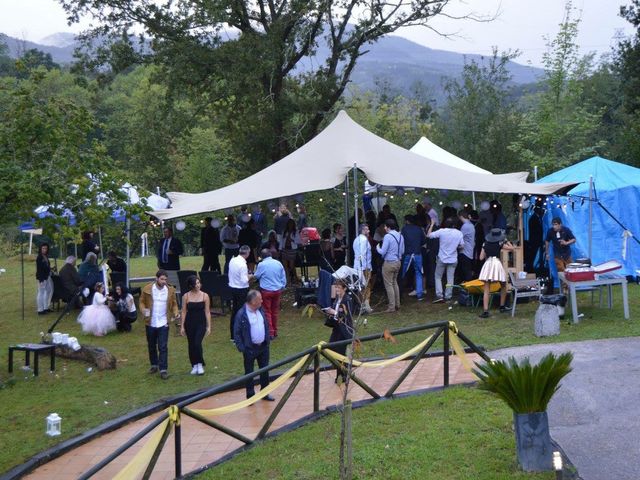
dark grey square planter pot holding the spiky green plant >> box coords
[513,412,553,472]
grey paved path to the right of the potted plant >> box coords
[490,337,640,480]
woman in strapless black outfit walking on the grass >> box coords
[180,275,211,375]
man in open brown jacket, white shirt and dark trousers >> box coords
[139,270,180,380]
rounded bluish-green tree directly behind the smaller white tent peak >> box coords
[432,48,523,173]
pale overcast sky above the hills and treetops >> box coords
[0,0,633,66]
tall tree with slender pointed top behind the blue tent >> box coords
[511,2,604,175]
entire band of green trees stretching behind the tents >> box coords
[0,0,640,240]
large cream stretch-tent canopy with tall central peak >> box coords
[149,111,575,219]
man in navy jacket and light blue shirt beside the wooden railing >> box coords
[233,290,275,402]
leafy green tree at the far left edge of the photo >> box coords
[0,70,124,236]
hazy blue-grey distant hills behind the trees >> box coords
[0,32,543,104]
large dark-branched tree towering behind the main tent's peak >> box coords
[59,0,470,168]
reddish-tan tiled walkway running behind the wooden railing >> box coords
[26,355,479,480]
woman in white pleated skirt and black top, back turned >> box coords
[478,228,513,318]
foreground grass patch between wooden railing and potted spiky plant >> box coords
[198,387,555,480]
